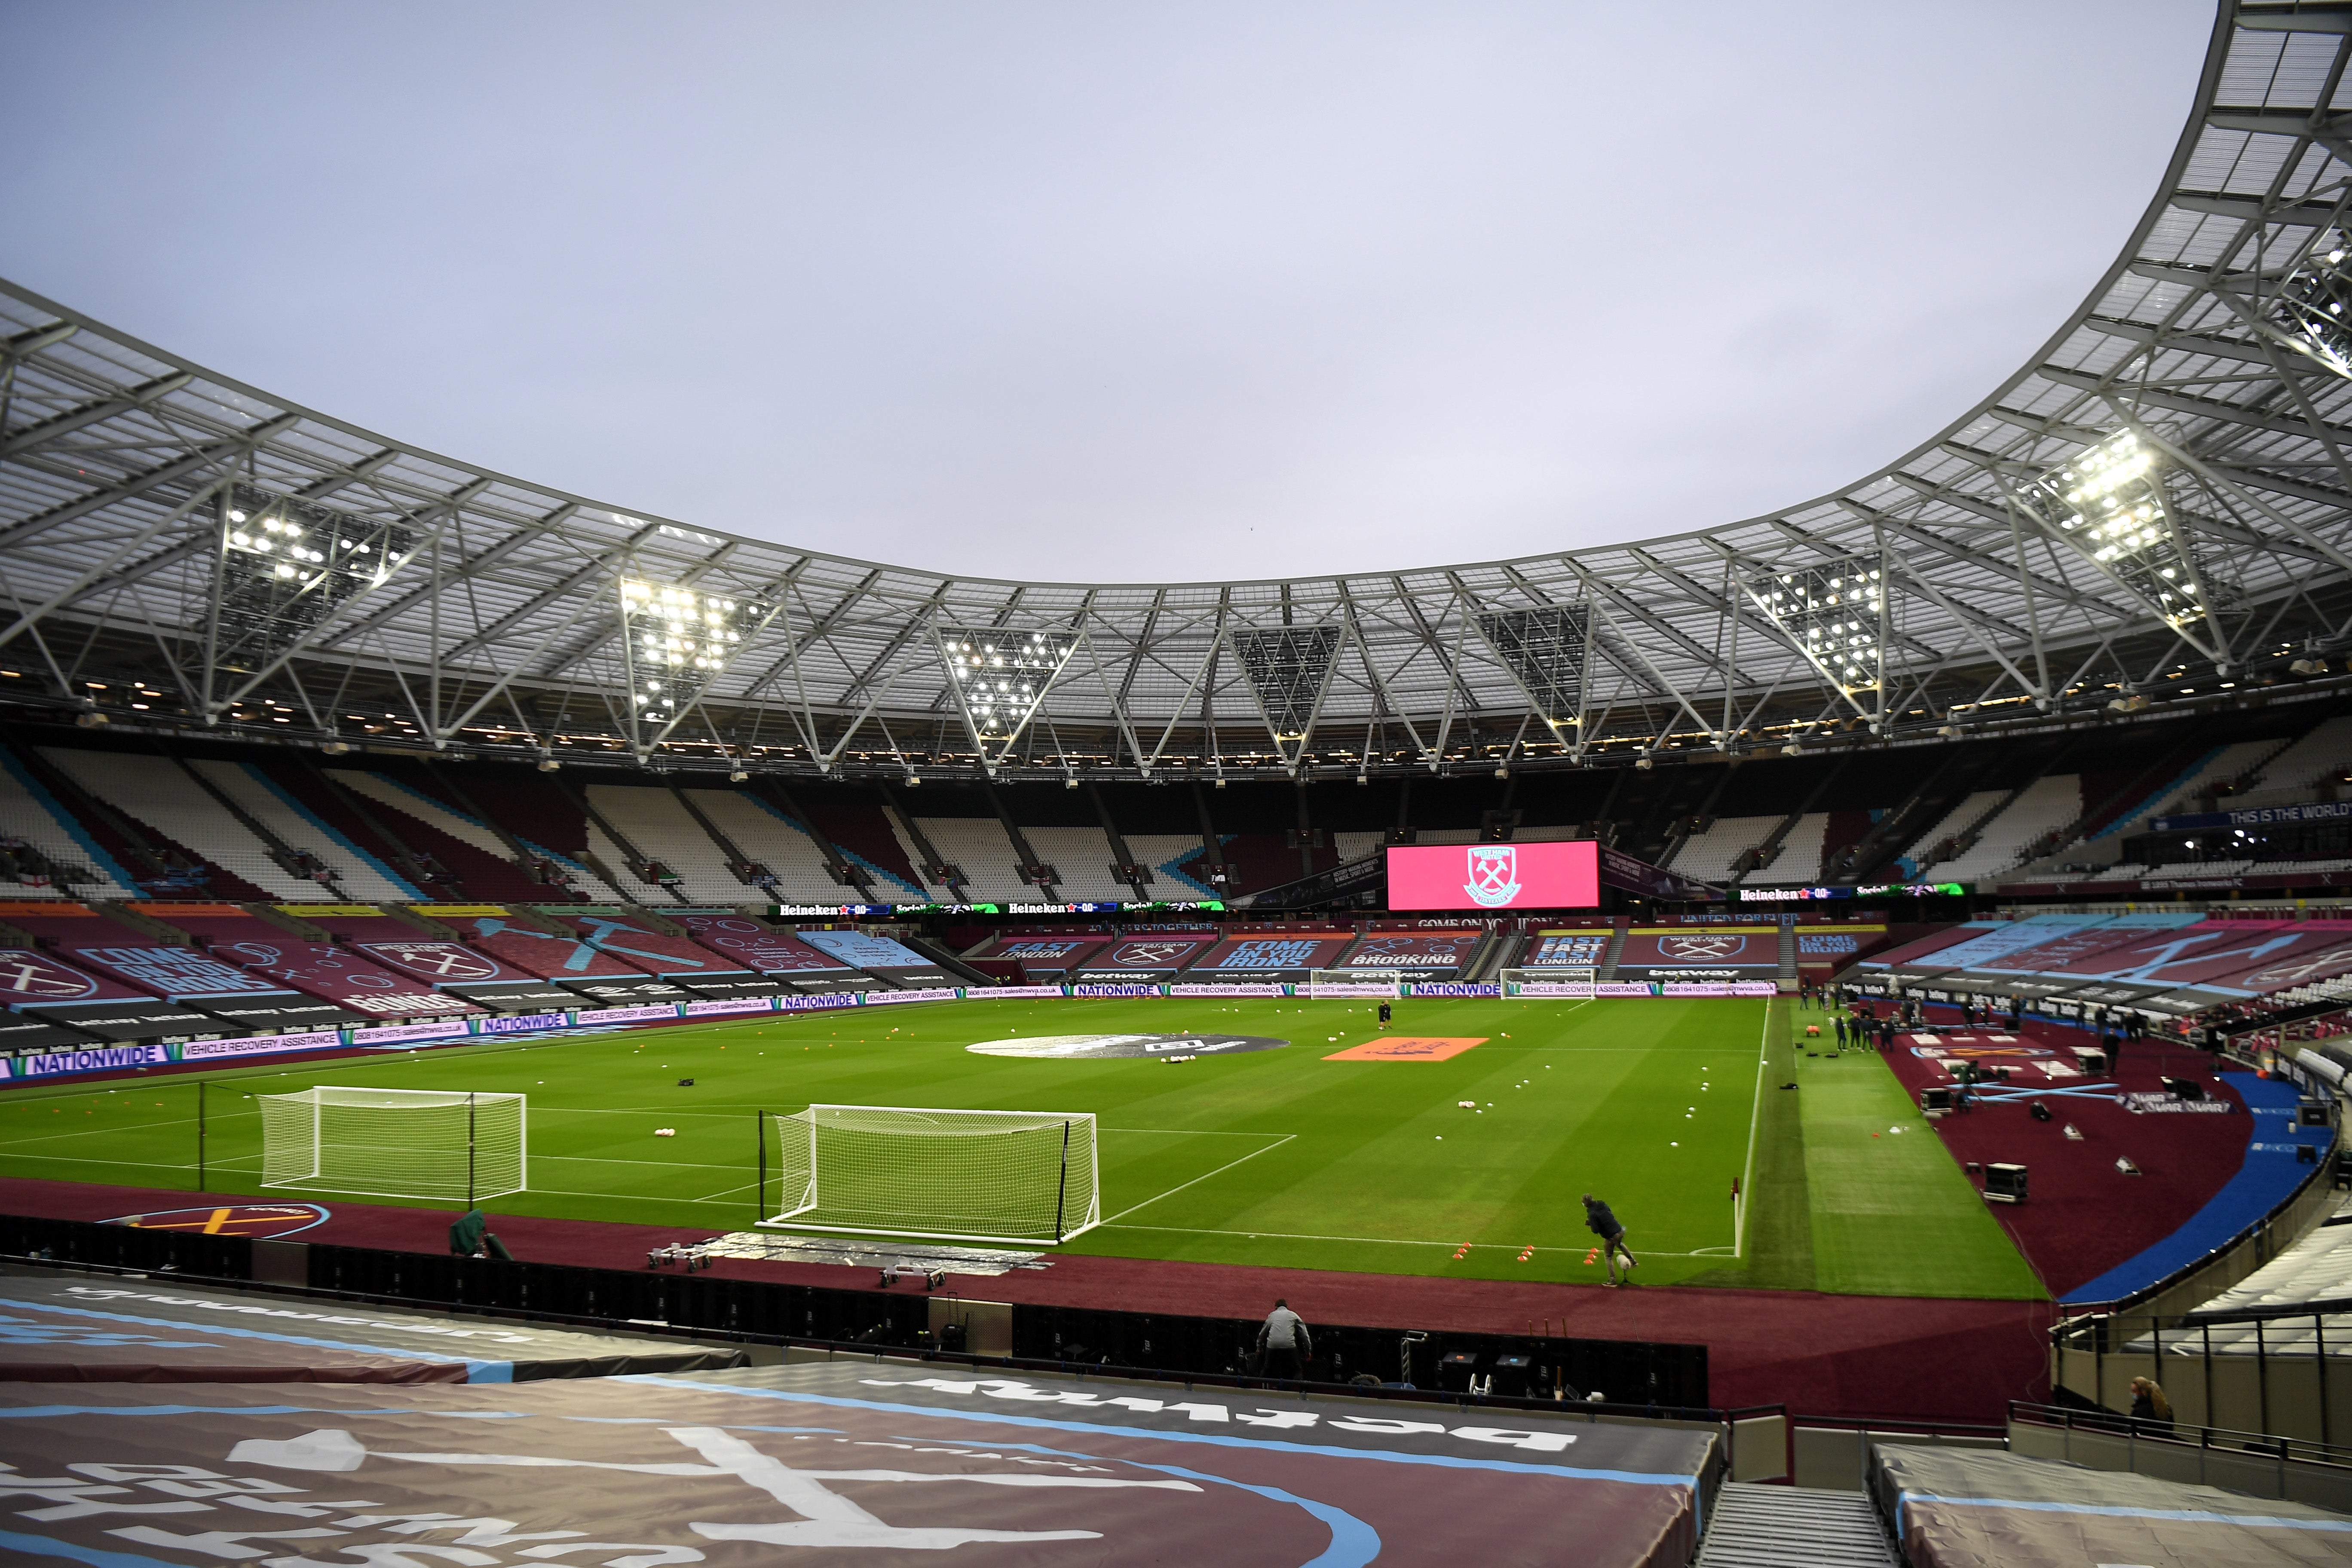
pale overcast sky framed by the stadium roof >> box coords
[0,0,2213,581]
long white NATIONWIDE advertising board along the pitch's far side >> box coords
[0,973,1778,1088]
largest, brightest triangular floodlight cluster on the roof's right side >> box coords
[2020,430,2230,663]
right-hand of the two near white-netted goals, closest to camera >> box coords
[760,1105,1103,1246]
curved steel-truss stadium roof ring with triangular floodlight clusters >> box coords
[0,2,2352,776]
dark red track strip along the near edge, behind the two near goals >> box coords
[0,1175,2051,1424]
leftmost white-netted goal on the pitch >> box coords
[259,1084,529,1204]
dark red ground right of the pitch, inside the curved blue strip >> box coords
[1886,1020,2253,1298]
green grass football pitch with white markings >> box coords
[0,997,2044,1298]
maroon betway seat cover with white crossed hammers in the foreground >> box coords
[0,1357,1719,1568]
